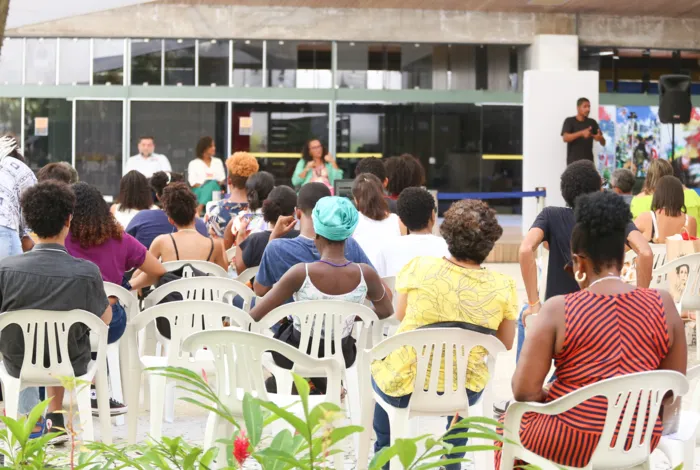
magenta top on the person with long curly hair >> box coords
[66,232,147,285]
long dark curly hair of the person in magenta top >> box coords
[70,183,124,248]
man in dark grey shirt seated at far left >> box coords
[0,181,112,440]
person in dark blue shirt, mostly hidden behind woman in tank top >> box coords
[126,171,209,248]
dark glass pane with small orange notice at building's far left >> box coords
[24,98,73,171]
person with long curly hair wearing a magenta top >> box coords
[65,182,165,415]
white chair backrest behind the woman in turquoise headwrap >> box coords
[257,300,378,359]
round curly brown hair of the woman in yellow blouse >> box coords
[440,199,503,264]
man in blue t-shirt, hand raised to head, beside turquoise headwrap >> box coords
[254,183,372,296]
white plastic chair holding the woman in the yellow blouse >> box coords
[357,328,506,470]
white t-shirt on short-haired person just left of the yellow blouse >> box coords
[374,234,450,277]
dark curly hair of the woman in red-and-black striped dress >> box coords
[571,192,632,273]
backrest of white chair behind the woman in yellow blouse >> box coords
[360,328,506,417]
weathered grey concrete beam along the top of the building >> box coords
[8,0,700,49]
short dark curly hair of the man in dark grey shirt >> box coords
[20,180,75,238]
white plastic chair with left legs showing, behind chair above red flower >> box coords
[127,300,252,443]
